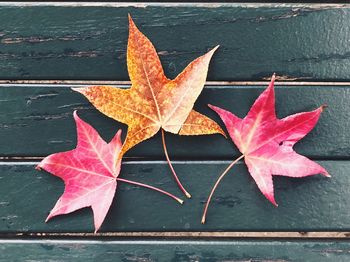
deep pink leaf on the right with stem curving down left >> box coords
[202,75,330,224]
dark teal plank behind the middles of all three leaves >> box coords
[0,85,350,160]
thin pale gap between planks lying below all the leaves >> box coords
[6,231,350,239]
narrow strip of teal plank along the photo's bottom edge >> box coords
[0,240,350,262]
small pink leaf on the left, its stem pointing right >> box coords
[37,111,182,232]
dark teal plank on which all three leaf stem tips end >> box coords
[0,161,350,233]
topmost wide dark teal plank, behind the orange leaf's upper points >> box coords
[0,3,350,81]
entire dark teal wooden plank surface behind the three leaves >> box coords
[0,1,350,262]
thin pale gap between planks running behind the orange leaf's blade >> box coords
[0,79,350,87]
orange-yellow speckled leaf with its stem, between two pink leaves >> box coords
[73,15,225,197]
